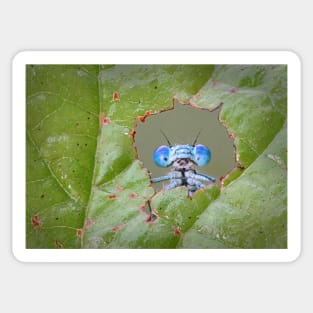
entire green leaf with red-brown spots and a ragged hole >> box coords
[26,65,287,248]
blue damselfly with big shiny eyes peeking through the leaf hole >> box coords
[151,131,216,197]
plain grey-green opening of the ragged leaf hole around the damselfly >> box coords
[135,100,236,191]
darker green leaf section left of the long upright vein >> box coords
[26,65,99,248]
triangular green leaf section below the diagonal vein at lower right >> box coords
[180,123,287,249]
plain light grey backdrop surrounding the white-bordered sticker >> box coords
[0,0,313,312]
